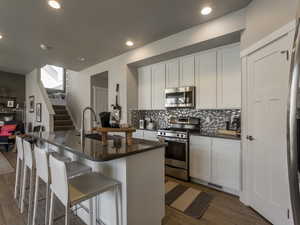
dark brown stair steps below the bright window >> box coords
[53,105,75,131]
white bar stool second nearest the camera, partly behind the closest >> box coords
[32,146,91,225]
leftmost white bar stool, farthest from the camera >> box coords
[14,136,24,204]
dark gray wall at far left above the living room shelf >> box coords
[0,71,25,105]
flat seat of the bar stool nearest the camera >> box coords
[69,172,119,206]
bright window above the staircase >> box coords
[41,65,65,91]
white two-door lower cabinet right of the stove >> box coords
[190,135,241,193]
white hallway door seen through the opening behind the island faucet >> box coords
[93,86,108,115]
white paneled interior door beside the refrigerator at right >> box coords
[247,35,290,225]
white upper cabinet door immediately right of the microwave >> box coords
[195,50,217,109]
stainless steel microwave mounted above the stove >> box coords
[165,87,195,108]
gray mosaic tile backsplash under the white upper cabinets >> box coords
[129,108,241,134]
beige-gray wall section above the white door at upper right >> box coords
[241,0,299,49]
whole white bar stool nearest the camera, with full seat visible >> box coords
[49,156,122,225]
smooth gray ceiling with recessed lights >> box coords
[0,0,251,74]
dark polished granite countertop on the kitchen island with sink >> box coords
[29,130,165,162]
